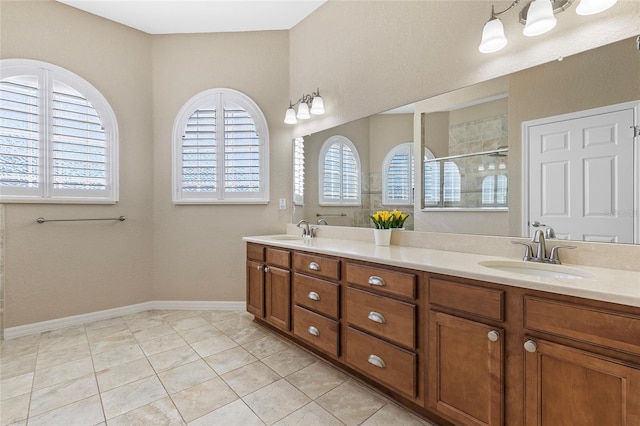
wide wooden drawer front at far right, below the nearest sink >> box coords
[524,296,640,354]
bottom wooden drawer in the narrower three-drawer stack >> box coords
[293,306,340,357]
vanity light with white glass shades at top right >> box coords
[478,0,618,53]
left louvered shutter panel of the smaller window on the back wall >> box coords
[181,107,217,192]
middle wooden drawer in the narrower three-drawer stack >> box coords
[293,274,340,319]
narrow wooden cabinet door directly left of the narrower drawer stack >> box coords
[265,266,291,331]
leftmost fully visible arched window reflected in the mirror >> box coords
[318,136,361,206]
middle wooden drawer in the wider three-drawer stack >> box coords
[346,288,416,349]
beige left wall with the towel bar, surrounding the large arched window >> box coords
[0,0,153,327]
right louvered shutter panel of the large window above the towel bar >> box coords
[51,82,108,191]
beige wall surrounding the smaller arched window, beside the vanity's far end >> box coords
[152,31,292,301]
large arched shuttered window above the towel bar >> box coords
[0,59,118,203]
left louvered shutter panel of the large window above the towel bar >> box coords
[0,76,40,193]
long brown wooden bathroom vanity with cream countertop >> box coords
[245,235,640,426]
